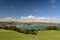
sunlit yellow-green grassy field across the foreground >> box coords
[0,29,60,40]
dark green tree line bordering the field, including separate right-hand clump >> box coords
[0,26,58,35]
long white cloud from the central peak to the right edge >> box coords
[20,15,60,22]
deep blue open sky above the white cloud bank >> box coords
[0,0,60,17]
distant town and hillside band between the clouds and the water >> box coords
[0,21,60,27]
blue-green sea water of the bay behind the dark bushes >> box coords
[17,26,60,30]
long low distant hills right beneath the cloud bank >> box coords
[0,21,60,26]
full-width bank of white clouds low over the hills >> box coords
[0,15,60,23]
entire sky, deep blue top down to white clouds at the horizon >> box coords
[0,0,60,22]
